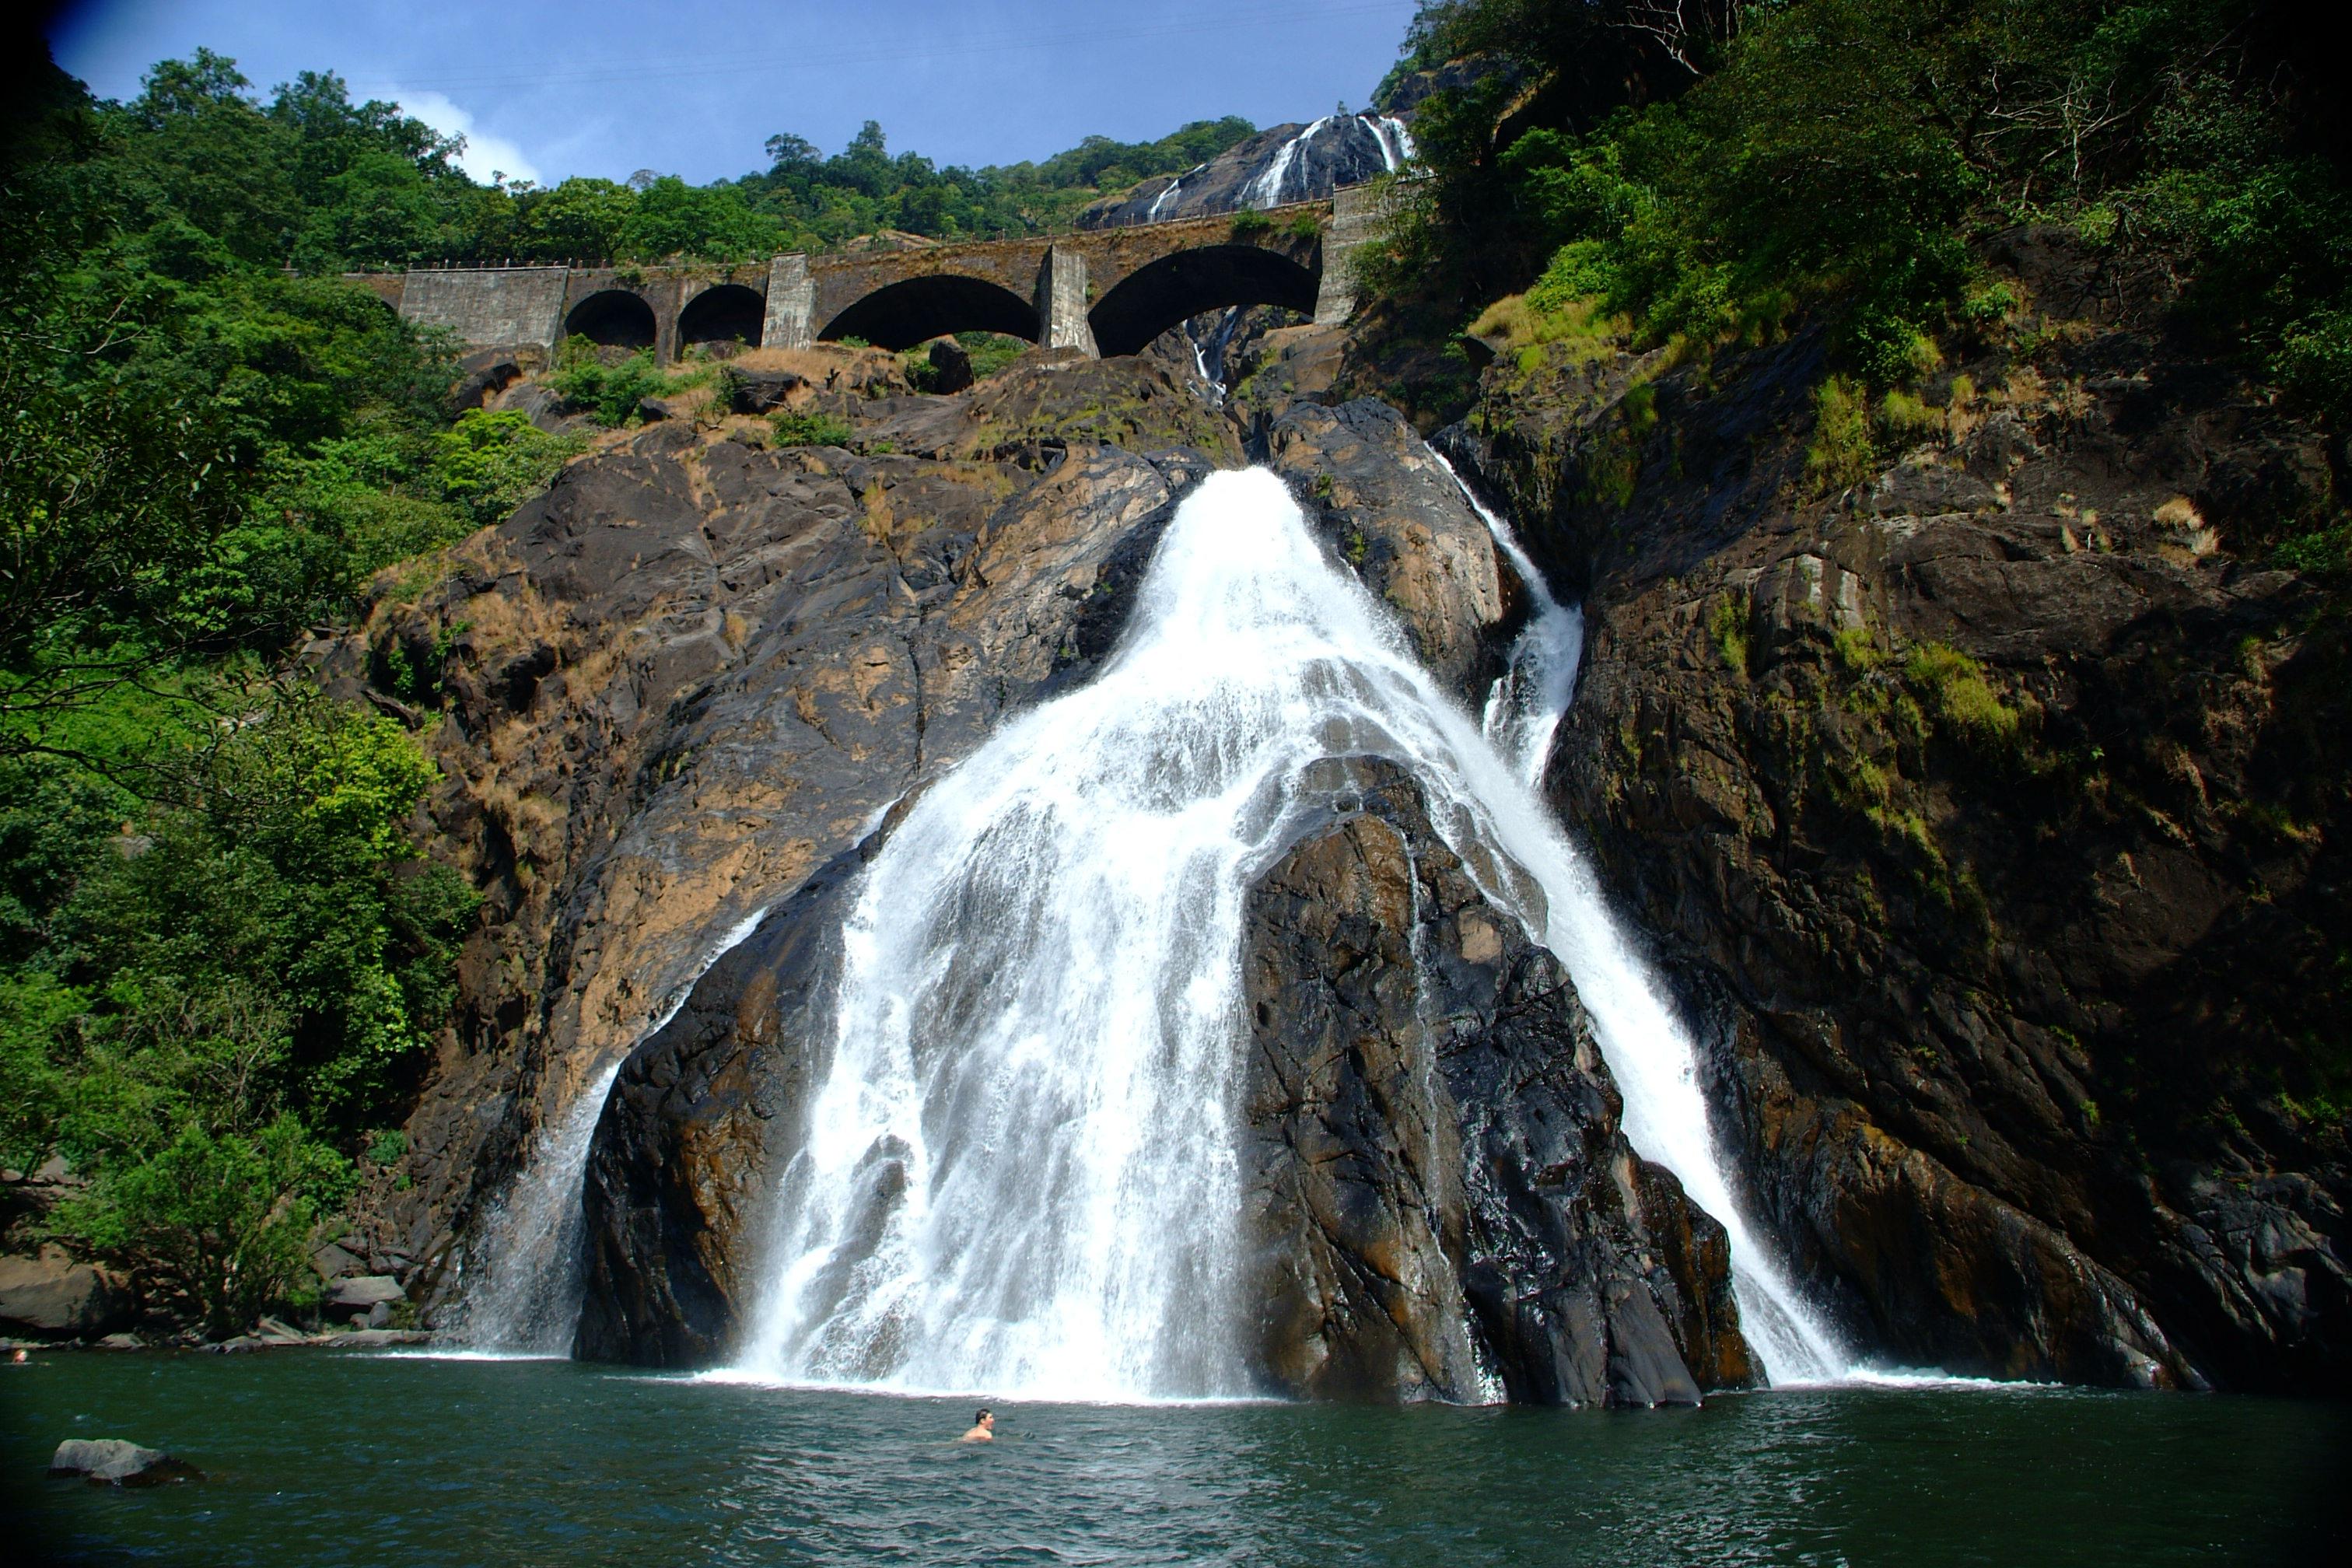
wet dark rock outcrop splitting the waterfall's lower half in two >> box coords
[1242,759,1752,1405]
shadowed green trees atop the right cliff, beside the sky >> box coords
[1371,0,2352,414]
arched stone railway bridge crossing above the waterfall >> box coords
[353,186,1374,364]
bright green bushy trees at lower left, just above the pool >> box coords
[0,682,475,1331]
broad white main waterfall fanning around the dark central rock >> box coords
[737,470,1837,1398]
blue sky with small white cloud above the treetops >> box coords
[50,0,1413,184]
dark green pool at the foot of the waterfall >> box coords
[0,1352,2352,1568]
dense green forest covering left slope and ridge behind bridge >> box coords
[0,51,1251,1331]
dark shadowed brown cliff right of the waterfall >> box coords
[1458,233,2352,1389]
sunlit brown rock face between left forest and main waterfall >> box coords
[343,359,1240,1307]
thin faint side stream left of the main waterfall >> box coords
[459,902,775,1356]
